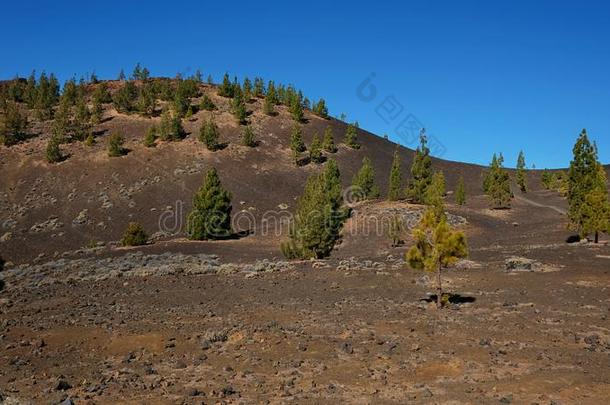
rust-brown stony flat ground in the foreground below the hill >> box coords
[0,194,610,404]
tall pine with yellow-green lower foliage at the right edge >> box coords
[567,129,609,242]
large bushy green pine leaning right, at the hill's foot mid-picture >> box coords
[281,159,349,259]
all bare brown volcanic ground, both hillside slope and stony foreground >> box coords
[0,80,610,405]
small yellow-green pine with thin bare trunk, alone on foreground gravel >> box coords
[406,207,468,309]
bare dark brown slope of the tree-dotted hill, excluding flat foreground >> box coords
[0,77,490,262]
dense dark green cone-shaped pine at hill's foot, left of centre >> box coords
[186,168,232,240]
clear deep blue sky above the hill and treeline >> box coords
[0,0,610,168]
